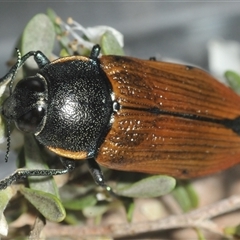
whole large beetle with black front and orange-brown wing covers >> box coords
[0,45,240,189]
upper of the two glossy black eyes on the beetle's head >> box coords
[16,76,45,92]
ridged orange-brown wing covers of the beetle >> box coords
[96,56,240,178]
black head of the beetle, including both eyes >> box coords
[2,75,47,133]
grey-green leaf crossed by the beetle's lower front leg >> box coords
[24,134,59,198]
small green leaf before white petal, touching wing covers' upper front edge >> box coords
[100,31,124,55]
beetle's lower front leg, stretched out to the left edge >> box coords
[0,158,75,190]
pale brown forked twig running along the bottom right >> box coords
[44,195,240,238]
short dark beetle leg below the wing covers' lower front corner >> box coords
[87,158,117,197]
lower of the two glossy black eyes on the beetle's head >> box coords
[16,107,45,133]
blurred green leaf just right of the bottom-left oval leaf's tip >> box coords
[63,195,97,210]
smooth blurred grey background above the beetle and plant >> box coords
[0,1,240,176]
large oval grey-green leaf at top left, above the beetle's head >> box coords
[21,13,55,68]
